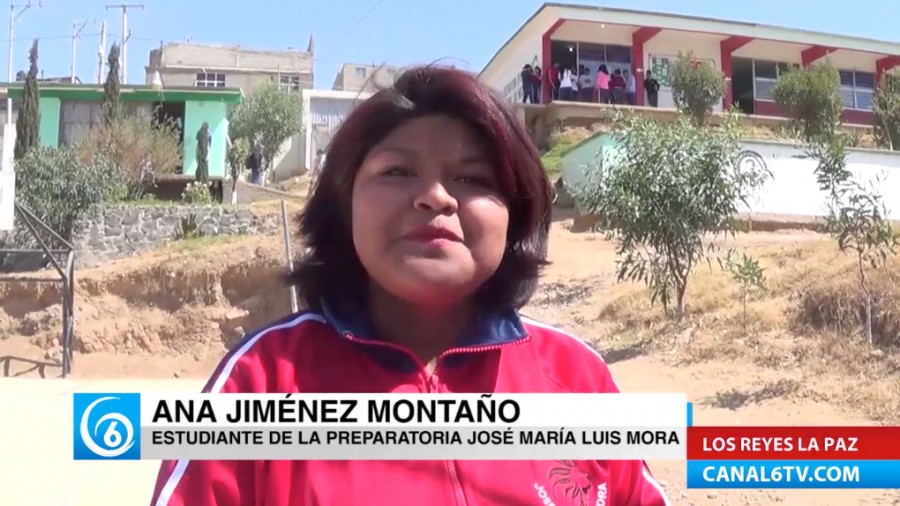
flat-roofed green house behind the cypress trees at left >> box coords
[0,83,243,182]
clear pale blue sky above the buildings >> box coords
[7,0,900,88]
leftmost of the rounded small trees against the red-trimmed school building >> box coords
[670,52,725,124]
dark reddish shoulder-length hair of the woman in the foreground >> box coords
[290,65,554,310]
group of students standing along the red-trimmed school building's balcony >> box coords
[522,63,659,107]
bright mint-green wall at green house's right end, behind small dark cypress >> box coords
[183,101,228,177]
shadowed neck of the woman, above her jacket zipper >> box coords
[368,289,472,365]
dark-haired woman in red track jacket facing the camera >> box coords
[153,67,668,506]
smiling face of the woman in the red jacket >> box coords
[352,116,509,306]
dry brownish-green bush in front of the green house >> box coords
[79,114,182,199]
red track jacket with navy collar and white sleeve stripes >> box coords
[152,308,669,506]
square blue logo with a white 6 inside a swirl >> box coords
[72,393,141,460]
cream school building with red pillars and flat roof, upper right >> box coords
[480,3,900,125]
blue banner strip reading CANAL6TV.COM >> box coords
[687,460,900,489]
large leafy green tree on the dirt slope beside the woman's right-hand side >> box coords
[572,114,768,320]
